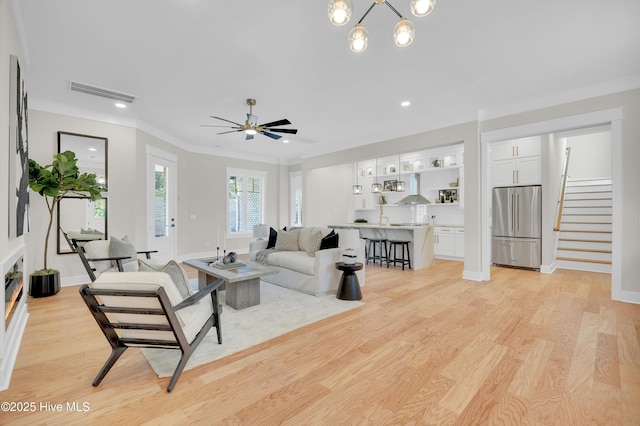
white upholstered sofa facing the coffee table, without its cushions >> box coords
[249,227,365,296]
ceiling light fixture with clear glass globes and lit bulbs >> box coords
[327,0,437,52]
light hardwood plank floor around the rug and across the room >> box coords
[0,260,640,425]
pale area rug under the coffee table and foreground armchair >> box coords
[142,281,363,377]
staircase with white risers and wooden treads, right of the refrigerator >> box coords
[556,179,612,273]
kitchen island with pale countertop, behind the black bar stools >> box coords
[329,223,434,270]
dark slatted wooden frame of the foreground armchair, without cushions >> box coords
[80,278,224,392]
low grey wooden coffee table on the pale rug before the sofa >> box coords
[184,258,278,309]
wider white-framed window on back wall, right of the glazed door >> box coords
[227,169,267,235]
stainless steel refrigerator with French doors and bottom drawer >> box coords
[491,185,542,270]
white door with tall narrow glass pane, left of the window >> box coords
[147,149,178,264]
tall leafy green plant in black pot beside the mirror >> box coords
[29,151,102,297]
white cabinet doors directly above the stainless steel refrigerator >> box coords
[491,136,542,187]
